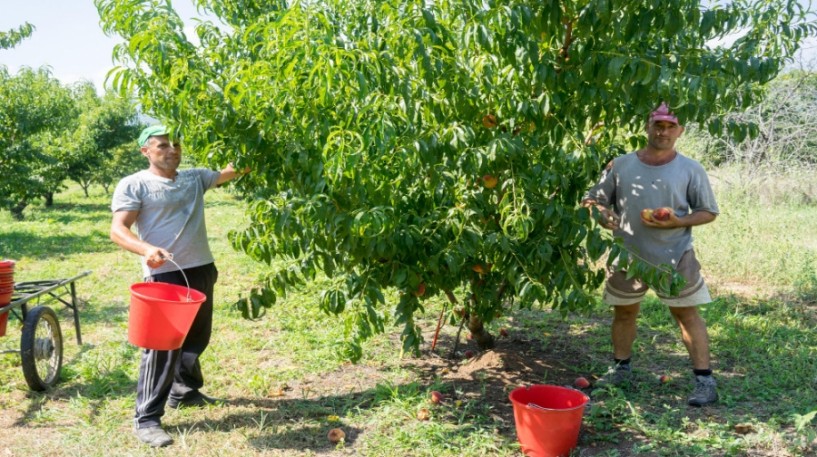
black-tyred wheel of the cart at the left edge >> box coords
[20,306,62,392]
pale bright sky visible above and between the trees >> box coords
[0,0,817,92]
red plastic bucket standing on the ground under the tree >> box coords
[510,385,590,457]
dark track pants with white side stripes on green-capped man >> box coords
[134,263,218,428]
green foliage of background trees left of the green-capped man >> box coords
[0,68,144,217]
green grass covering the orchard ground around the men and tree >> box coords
[0,173,817,456]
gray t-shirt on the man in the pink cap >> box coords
[585,152,719,267]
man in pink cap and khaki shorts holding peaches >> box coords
[583,103,719,406]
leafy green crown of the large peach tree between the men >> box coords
[96,0,814,359]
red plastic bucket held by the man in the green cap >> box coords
[128,282,207,351]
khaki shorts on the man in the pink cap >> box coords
[602,249,712,307]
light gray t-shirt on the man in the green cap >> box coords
[111,168,220,277]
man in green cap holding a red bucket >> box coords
[111,125,247,447]
